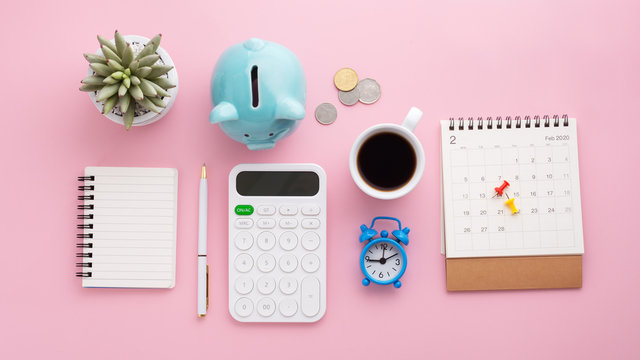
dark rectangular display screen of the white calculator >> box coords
[236,171,320,196]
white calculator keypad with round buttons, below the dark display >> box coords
[229,203,326,321]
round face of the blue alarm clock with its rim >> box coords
[360,238,407,284]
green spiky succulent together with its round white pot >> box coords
[80,30,178,130]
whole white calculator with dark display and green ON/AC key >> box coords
[229,164,327,322]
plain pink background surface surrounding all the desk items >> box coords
[0,0,640,359]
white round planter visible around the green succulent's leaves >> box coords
[87,35,178,126]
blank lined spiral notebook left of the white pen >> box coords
[76,167,178,288]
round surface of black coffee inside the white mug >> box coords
[357,132,417,191]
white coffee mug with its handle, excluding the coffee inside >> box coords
[349,107,424,200]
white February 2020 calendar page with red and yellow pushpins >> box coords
[441,117,584,258]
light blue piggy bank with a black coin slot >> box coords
[209,38,306,150]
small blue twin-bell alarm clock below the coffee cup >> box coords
[360,216,410,288]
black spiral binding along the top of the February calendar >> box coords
[449,114,569,131]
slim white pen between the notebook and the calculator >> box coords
[198,164,209,317]
